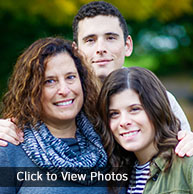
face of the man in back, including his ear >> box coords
[77,15,133,80]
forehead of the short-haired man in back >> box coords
[78,15,123,38]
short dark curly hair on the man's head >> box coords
[72,1,129,43]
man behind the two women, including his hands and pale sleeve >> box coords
[0,1,193,156]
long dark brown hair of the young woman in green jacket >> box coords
[97,67,180,171]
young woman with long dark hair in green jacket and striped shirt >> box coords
[97,67,193,194]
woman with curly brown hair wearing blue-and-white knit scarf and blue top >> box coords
[0,37,107,194]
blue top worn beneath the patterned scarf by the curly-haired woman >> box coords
[0,138,125,194]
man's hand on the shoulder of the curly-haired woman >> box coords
[0,119,24,146]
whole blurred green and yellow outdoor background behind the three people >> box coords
[0,0,193,128]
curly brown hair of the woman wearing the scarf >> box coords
[1,37,99,128]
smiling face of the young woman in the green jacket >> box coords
[109,89,155,163]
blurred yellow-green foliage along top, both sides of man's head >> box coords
[0,0,193,25]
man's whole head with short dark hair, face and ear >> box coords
[72,1,133,81]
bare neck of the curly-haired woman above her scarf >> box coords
[45,120,76,138]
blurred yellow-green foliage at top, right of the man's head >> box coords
[110,0,193,21]
